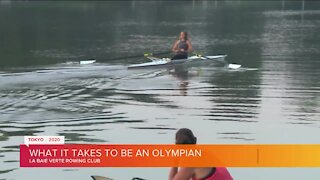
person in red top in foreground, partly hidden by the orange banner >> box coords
[169,128,233,180]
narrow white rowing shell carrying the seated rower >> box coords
[128,55,227,69]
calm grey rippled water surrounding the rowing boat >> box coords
[0,1,320,180]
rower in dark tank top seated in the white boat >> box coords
[172,32,192,59]
